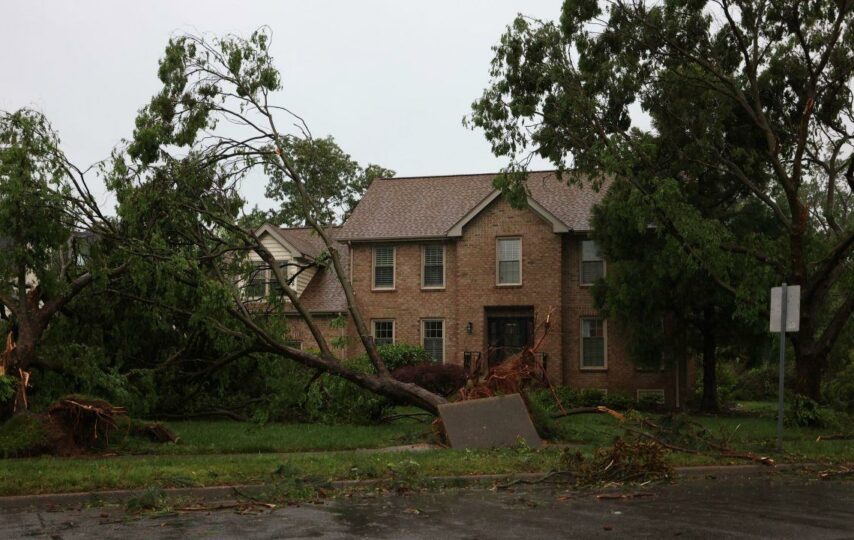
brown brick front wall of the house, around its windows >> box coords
[342,198,693,404]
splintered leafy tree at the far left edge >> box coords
[0,109,124,420]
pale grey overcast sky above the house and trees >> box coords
[0,0,561,211]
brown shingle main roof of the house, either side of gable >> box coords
[338,171,605,240]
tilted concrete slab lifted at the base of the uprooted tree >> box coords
[439,394,543,448]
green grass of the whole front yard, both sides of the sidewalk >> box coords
[0,403,854,495]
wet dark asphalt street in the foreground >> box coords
[0,476,854,540]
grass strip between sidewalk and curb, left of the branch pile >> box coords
[0,448,559,495]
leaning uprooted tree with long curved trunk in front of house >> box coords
[107,30,445,412]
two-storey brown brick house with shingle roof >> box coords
[252,172,690,406]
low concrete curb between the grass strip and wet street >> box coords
[0,463,816,512]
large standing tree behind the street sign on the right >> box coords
[470,0,854,398]
